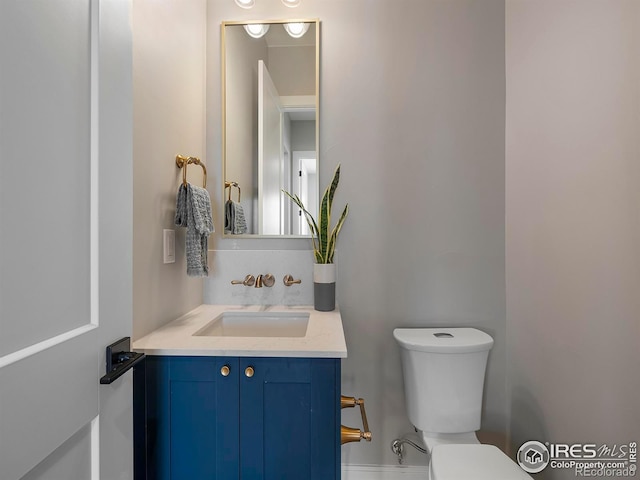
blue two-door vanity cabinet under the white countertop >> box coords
[136,356,340,480]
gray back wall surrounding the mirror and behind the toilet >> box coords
[207,0,507,464]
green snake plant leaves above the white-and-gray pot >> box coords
[283,164,349,263]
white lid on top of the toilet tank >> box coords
[393,328,493,353]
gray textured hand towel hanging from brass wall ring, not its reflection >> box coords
[175,184,214,277]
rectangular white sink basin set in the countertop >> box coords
[193,312,309,337]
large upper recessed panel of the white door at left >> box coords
[0,0,91,356]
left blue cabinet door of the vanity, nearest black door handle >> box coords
[147,357,239,480]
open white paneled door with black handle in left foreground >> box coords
[0,0,133,480]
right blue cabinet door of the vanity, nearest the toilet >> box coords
[240,358,340,480]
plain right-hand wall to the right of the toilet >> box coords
[506,0,640,479]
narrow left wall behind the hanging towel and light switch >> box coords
[132,0,209,339]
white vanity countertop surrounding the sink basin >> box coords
[133,305,347,358]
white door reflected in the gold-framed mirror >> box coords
[258,60,283,235]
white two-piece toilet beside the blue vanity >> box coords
[393,328,532,480]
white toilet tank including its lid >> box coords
[393,328,493,433]
